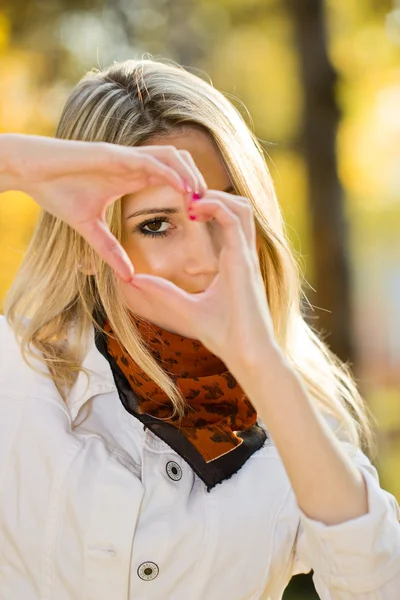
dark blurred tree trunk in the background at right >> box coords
[285,0,354,363]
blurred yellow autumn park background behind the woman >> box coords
[0,0,400,600]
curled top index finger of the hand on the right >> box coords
[189,190,256,248]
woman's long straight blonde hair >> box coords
[5,59,373,451]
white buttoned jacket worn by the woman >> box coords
[0,317,400,600]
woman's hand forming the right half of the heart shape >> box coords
[126,190,277,366]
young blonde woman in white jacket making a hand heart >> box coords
[0,60,400,600]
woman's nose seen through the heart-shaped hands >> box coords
[185,221,219,278]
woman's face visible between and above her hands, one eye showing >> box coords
[122,129,233,296]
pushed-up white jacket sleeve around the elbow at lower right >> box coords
[293,442,400,600]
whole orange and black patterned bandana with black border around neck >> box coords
[96,314,266,488]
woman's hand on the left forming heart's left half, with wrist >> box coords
[0,134,207,282]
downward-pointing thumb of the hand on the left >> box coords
[76,219,135,283]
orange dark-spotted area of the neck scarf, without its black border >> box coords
[104,314,265,463]
